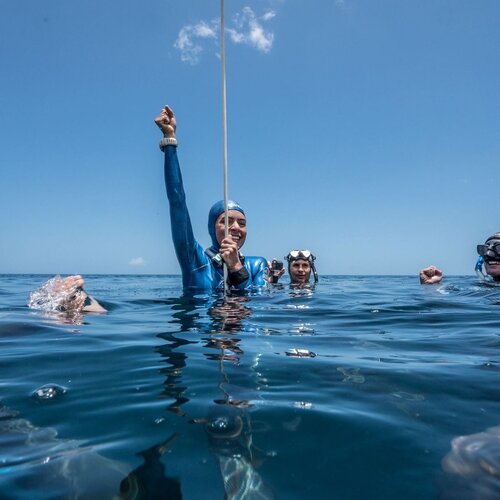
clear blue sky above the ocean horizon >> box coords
[0,0,500,274]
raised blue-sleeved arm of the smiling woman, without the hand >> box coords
[164,146,198,275]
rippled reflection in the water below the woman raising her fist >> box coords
[157,295,273,499]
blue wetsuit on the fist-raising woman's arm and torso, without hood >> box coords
[164,146,267,291]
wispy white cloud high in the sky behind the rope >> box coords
[174,7,276,65]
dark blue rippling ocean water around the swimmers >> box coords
[0,275,500,500]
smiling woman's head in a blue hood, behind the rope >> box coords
[208,200,247,250]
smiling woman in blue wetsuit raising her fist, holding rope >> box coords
[155,106,267,290]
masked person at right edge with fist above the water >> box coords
[419,233,500,285]
